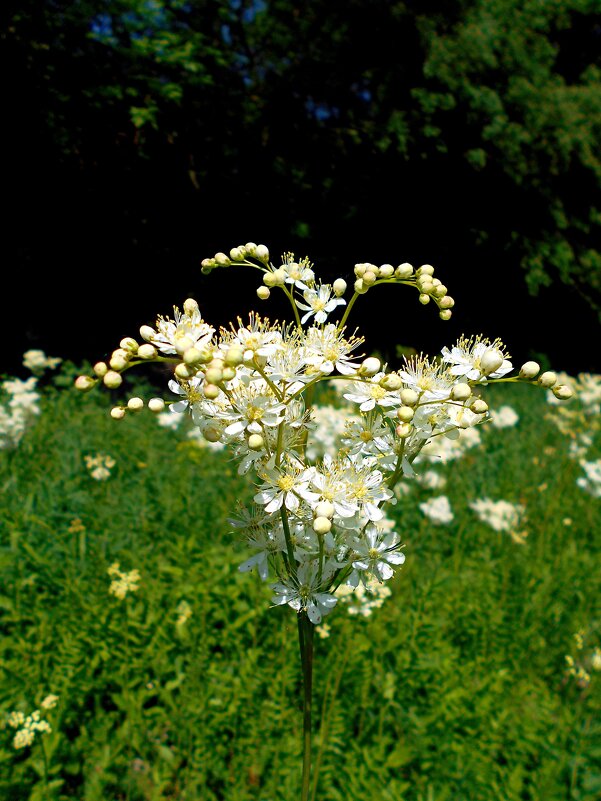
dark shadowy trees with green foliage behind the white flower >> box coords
[0,0,601,373]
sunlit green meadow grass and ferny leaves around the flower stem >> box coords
[0,371,601,801]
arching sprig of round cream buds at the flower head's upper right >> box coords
[355,262,455,320]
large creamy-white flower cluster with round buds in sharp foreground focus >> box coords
[76,242,571,624]
